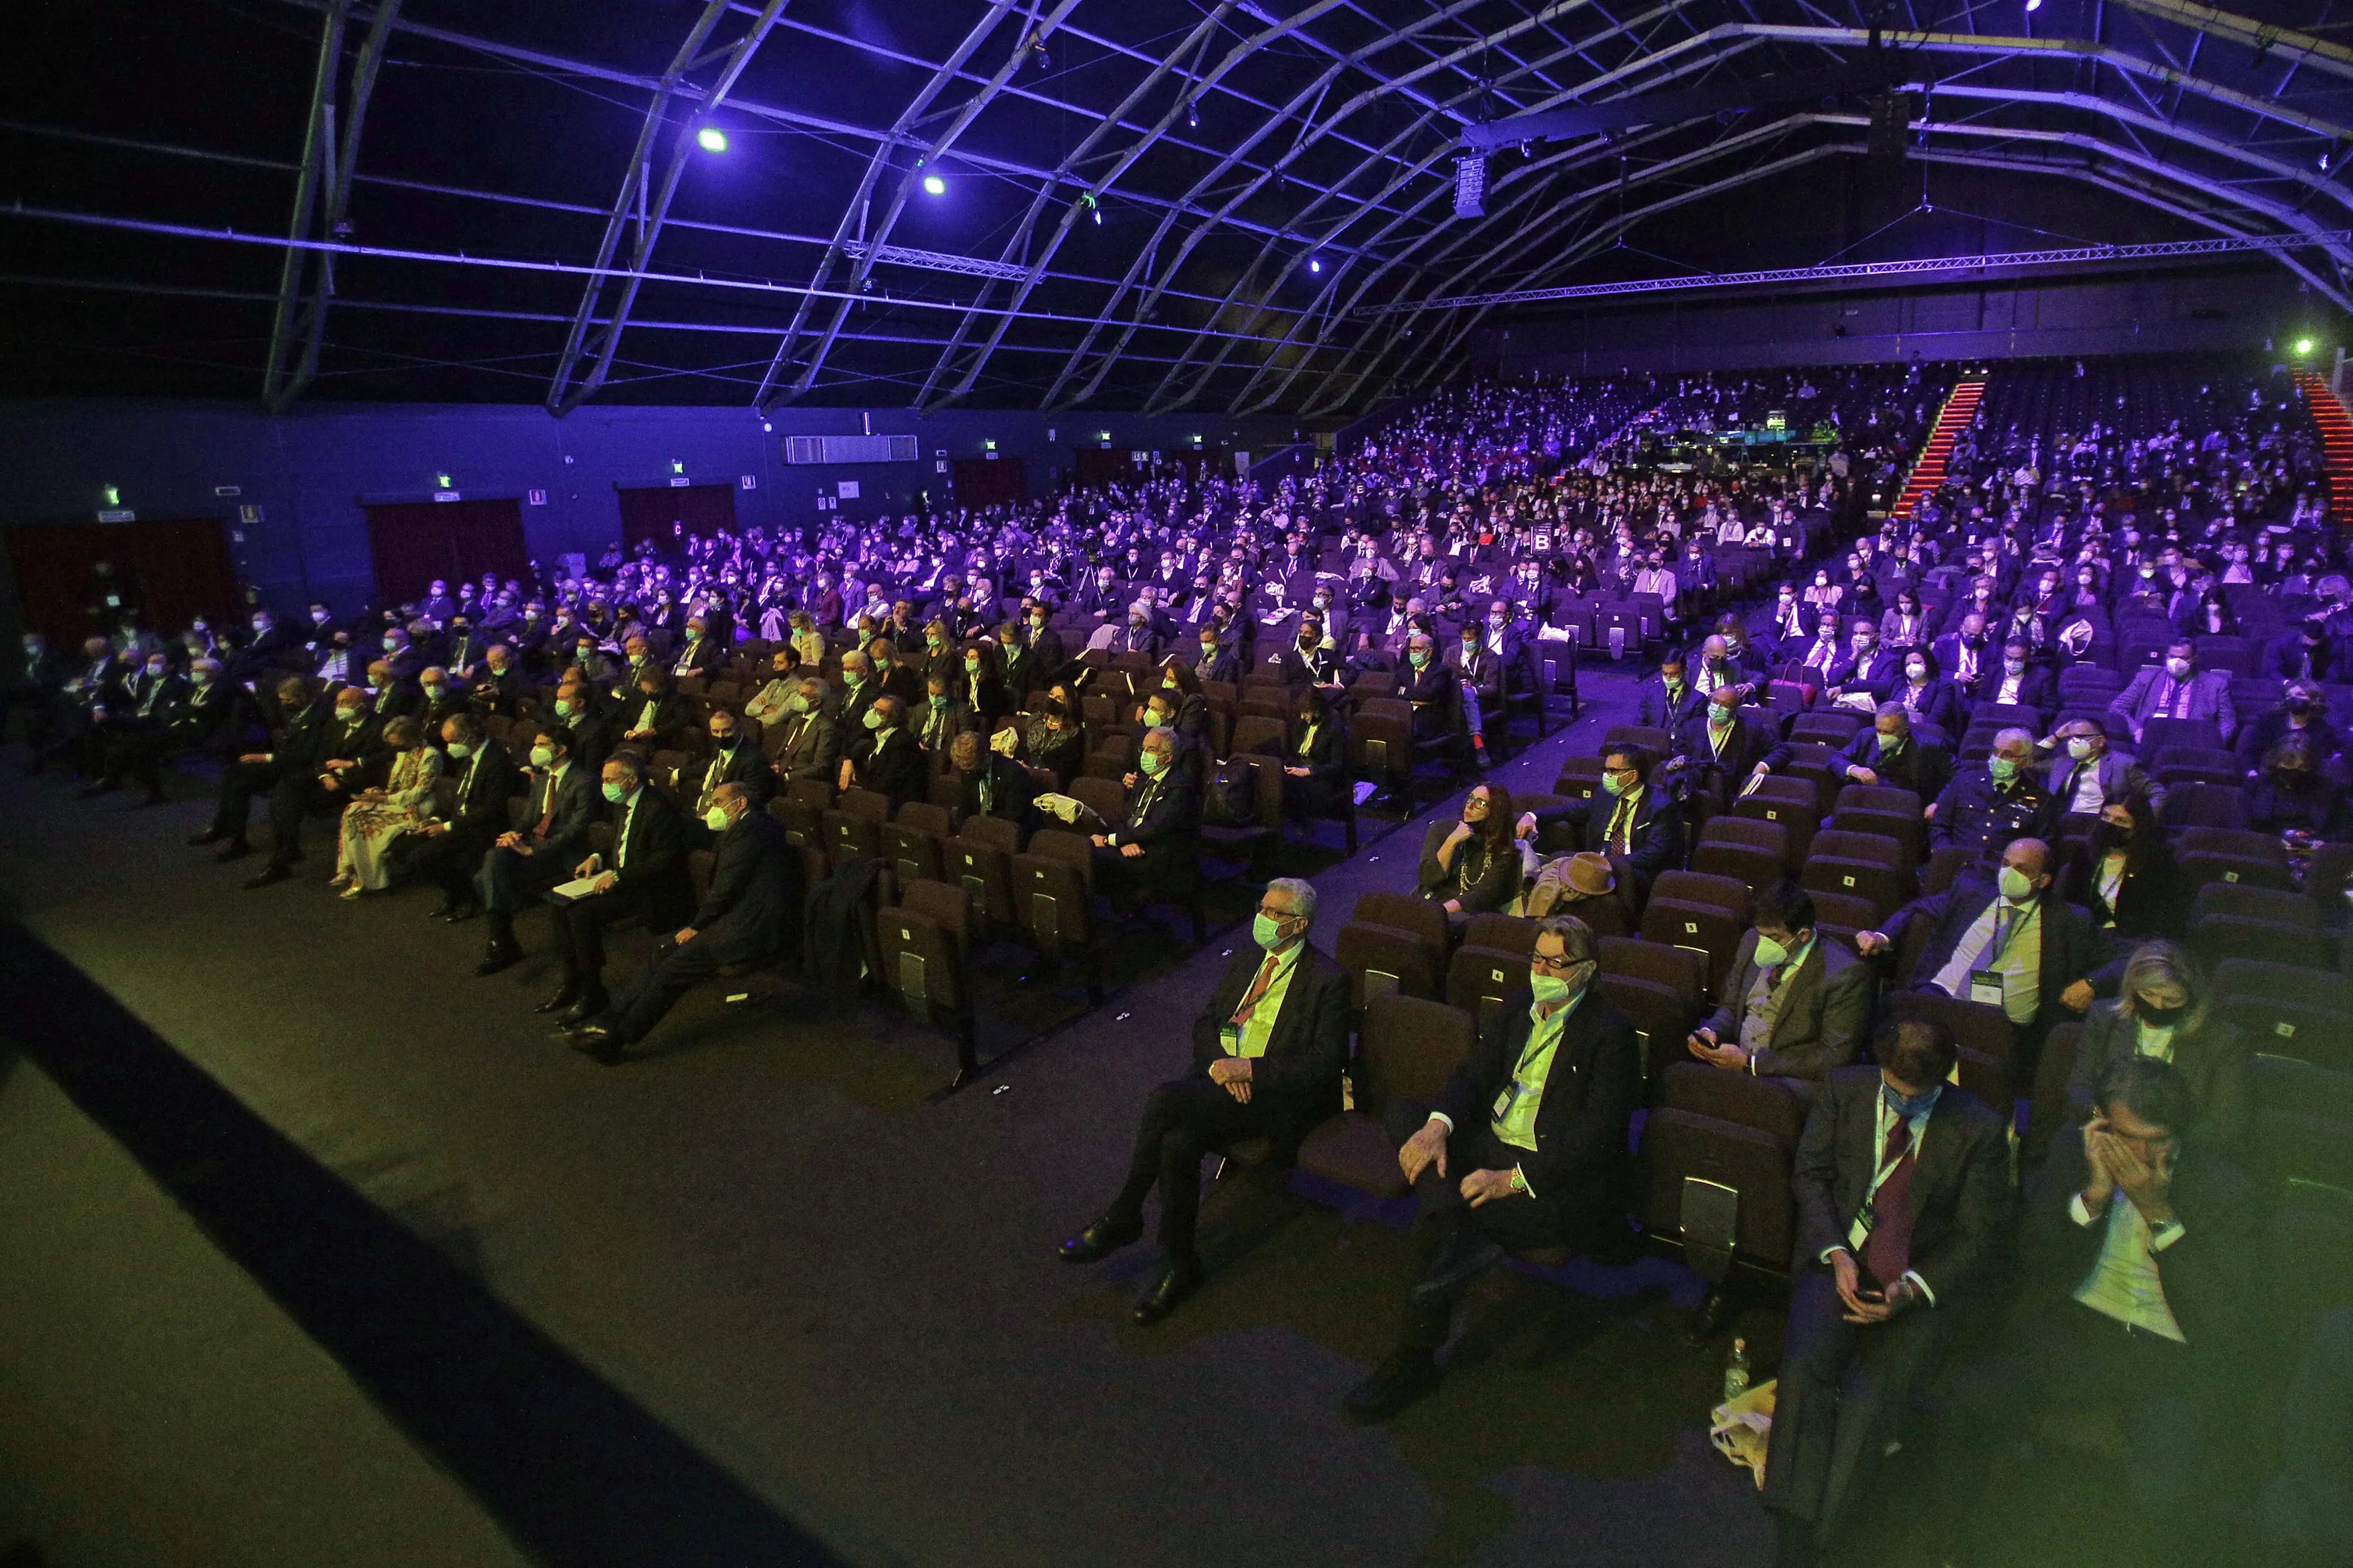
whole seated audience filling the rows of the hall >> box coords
[0,358,2353,1561]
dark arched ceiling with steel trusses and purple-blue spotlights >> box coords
[0,0,2353,415]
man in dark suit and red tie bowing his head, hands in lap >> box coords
[1762,1019,2009,1566]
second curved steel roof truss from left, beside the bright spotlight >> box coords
[548,0,786,415]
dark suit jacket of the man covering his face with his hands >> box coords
[2014,1125,2249,1370]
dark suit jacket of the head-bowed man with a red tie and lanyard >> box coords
[1791,1066,2012,1309]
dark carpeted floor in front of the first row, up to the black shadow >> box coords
[0,671,1779,1566]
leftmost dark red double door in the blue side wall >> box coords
[7,518,240,648]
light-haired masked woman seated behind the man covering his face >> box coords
[2066,942,2252,1151]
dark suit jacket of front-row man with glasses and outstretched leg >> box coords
[1433,986,1642,1243]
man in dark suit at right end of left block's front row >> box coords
[567,784,805,1066]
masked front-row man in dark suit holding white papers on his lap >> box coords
[539,751,708,1024]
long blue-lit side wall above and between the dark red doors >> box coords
[0,398,1294,612]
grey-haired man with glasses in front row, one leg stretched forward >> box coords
[1344,916,1642,1422]
